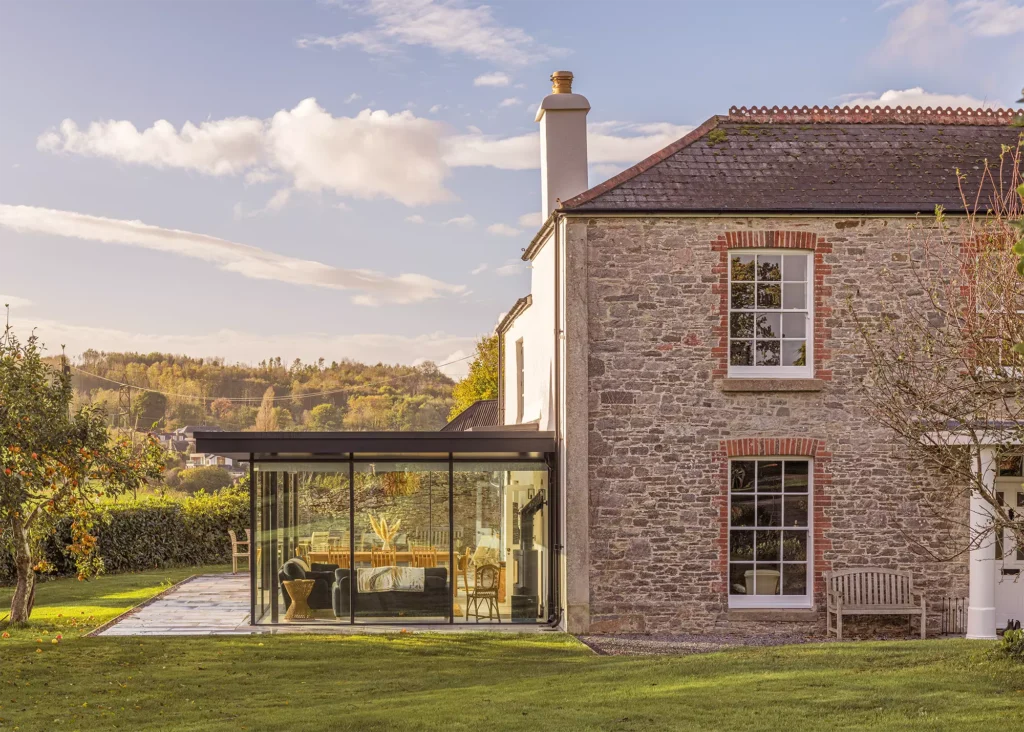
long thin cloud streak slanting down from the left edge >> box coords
[0,204,466,304]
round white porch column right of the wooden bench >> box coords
[967,447,995,640]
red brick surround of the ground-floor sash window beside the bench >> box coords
[718,437,831,609]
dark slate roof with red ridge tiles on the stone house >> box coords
[562,107,1024,213]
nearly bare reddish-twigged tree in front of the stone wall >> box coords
[851,146,1024,554]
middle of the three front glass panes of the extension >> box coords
[352,462,452,622]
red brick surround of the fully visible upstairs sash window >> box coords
[711,230,833,381]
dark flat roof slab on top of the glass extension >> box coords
[196,428,555,460]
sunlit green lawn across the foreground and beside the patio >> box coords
[0,570,1024,732]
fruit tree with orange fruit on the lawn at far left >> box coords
[0,326,163,625]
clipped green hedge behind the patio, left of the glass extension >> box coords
[0,490,249,585]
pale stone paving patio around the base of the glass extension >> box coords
[92,573,550,636]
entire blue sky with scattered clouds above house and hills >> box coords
[0,0,1024,376]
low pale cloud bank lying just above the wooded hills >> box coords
[11,312,476,378]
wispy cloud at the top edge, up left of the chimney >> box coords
[297,0,561,64]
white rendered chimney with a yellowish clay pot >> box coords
[537,72,590,218]
